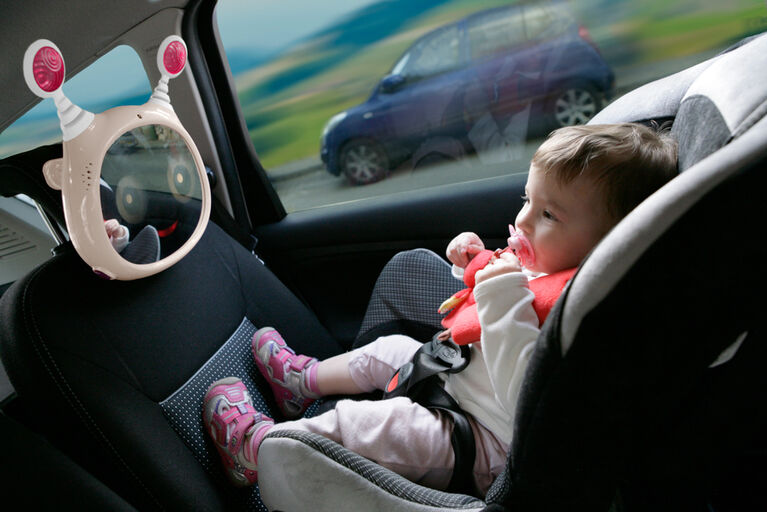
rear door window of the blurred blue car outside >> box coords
[467,7,527,59]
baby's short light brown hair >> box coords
[532,123,677,222]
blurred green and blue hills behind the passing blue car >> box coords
[220,0,767,170]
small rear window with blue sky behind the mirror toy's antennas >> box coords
[0,45,152,158]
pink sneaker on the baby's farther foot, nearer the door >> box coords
[251,327,320,418]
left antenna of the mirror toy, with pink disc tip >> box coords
[23,39,93,141]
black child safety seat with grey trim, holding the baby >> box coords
[259,36,767,512]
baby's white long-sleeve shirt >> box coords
[443,272,540,444]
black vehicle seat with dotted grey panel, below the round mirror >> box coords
[0,217,342,510]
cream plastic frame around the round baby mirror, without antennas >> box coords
[43,101,210,280]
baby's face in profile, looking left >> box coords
[516,166,613,274]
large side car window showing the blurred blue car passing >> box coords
[216,0,767,212]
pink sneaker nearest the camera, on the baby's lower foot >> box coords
[202,377,274,487]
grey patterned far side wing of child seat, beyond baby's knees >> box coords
[354,249,465,348]
